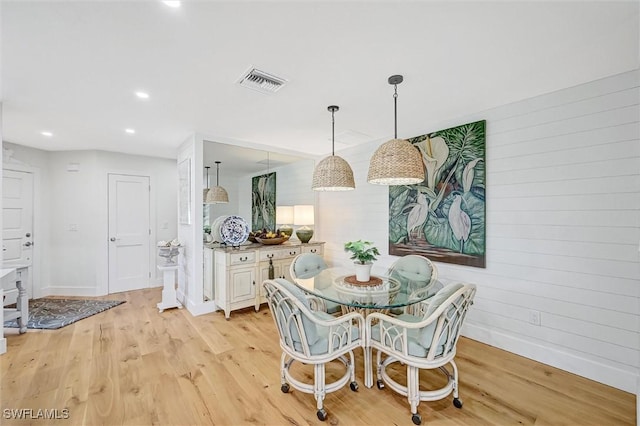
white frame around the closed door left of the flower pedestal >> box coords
[102,169,162,295]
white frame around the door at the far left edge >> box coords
[2,162,41,299]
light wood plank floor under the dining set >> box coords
[0,289,636,425]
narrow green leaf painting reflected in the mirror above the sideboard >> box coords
[251,172,276,231]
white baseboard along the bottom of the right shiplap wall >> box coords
[462,322,640,393]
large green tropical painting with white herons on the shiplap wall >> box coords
[389,120,486,268]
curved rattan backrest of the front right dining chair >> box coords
[419,283,476,360]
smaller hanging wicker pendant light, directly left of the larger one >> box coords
[311,105,356,191]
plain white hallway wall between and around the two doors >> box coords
[4,143,177,297]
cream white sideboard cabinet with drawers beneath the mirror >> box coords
[215,242,324,319]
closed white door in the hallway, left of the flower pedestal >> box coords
[109,174,151,293]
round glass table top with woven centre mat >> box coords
[294,268,442,309]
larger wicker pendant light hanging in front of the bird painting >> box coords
[367,75,424,185]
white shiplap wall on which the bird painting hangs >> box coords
[319,70,640,393]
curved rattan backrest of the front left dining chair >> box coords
[262,279,319,355]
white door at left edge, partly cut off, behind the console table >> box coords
[2,170,34,299]
